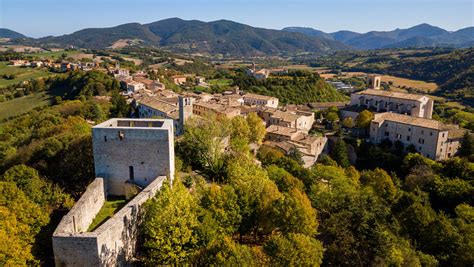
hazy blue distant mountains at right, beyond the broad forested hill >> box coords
[283,23,474,50]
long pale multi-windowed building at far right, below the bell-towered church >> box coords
[370,112,464,160]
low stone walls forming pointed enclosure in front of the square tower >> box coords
[53,176,166,266]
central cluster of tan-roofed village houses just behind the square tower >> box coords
[131,84,327,167]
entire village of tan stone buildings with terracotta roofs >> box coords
[107,62,464,167]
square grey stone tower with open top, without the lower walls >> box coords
[92,119,174,196]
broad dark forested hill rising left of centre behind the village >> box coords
[36,18,349,56]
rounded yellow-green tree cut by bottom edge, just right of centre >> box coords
[264,233,323,266]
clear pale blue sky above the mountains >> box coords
[0,0,474,37]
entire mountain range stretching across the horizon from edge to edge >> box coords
[0,18,474,56]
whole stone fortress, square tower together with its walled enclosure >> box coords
[53,119,174,266]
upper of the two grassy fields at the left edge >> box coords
[0,62,54,87]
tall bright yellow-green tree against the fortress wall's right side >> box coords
[141,182,199,265]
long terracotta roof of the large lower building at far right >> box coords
[372,112,448,131]
